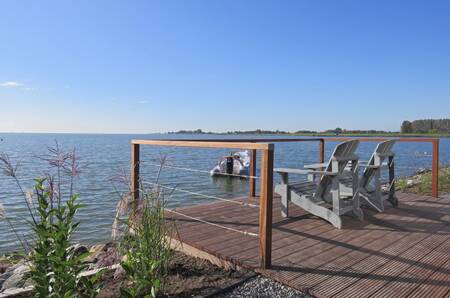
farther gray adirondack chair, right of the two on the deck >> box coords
[358,139,398,212]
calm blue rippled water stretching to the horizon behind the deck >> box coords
[0,133,450,253]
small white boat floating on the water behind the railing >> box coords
[210,151,250,178]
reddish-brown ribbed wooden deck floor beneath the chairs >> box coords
[170,193,450,297]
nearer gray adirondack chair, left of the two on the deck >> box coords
[274,140,363,229]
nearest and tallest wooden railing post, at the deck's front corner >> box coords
[259,144,274,269]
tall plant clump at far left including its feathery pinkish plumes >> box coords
[0,144,103,297]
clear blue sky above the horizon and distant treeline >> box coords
[0,0,450,133]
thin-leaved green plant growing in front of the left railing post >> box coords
[121,190,172,297]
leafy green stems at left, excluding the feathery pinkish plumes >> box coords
[29,178,102,297]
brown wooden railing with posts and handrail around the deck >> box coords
[131,137,439,269]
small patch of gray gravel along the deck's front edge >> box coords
[217,276,311,298]
